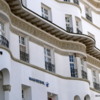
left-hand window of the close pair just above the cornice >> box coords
[65,15,73,33]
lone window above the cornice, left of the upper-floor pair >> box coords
[41,4,51,21]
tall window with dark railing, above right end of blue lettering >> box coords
[44,48,55,72]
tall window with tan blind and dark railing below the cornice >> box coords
[19,36,29,62]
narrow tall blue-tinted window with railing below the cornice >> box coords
[69,55,78,77]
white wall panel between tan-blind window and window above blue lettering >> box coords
[29,42,45,68]
